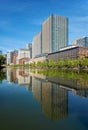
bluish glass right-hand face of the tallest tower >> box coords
[52,15,68,52]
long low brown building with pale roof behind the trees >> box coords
[48,46,88,61]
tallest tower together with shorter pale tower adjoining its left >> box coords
[32,15,68,58]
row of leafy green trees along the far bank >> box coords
[30,57,88,68]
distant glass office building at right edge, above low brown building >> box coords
[72,36,88,47]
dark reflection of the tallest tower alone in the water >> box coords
[42,81,68,120]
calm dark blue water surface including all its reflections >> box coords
[0,68,88,130]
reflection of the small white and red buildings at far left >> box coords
[7,68,32,90]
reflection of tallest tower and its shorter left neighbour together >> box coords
[32,77,68,120]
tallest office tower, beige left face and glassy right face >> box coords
[42,15,68,53]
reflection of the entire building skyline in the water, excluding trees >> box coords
[7,68,88,120]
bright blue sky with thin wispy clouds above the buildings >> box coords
[0,0,88,53]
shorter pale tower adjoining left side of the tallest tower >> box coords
[32,32,41,58]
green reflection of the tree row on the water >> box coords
[31,69,88,81]
